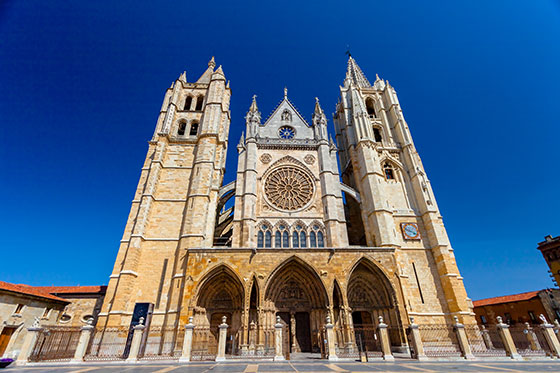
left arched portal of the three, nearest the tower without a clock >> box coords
[194,265,244,353]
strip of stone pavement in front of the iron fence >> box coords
[5,360,560,373]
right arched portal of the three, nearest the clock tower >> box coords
[347,259,404,346]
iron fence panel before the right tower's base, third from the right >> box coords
[418,324,461,357]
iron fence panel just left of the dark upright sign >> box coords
[84,326,132,360]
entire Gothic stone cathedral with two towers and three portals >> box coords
[97,57,475,352]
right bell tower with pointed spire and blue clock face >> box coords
[334,57,470,315]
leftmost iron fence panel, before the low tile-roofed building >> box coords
[29,326,81,361]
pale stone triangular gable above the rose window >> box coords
[259,90,313,139]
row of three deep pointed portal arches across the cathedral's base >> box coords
[190,256,406,353]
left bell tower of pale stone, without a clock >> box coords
[99,58,231,325]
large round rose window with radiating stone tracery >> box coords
[264,166,313,210]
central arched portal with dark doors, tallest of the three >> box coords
[265,257,328,352]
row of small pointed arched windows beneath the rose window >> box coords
[257,221,325,248]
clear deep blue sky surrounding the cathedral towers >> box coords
[0,0,560,299]
